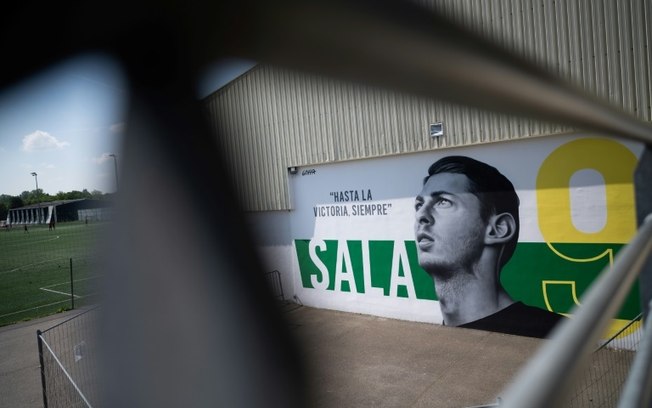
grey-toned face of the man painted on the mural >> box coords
[414,173,486,277]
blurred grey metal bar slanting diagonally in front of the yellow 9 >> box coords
[501,216,652,408]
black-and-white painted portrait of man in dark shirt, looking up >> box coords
[414,156,564,338]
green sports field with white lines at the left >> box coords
[0,222,106,326]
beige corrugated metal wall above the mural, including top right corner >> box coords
[205,0,652,211]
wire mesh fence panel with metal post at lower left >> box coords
[37,306,101,408]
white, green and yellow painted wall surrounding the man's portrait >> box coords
[249,134,642,342]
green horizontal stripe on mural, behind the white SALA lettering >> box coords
[295,240,640,319]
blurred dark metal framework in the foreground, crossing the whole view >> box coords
[0,0,652,407]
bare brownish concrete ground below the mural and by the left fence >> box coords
[0,306,545,408]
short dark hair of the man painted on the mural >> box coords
[423,156,520,267]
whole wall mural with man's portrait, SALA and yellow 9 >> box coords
[291,136,642,337]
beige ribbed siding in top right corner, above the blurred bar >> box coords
[430,0,652,121]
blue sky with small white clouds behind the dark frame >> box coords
[0,55,255,195]
